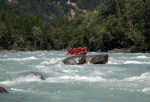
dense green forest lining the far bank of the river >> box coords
[0,0,150,51]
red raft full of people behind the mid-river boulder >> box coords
[67,47,88,55]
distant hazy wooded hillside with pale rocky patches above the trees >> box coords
[0,0,101,18]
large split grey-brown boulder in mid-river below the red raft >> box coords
[63,54,108,65]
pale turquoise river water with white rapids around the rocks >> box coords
[0,51,150,102]
